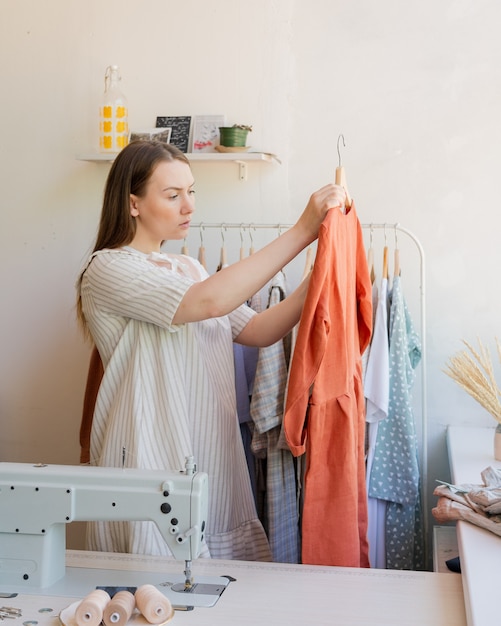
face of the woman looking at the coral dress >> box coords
[130,160,195,252]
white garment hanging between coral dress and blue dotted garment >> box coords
[364,278,390,569]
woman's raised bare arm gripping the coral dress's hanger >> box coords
[173,184,346,324]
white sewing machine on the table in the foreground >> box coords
[0,457,229,606]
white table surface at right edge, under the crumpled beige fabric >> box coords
[447,426,501,626]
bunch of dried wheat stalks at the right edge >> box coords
[444,339,501,423]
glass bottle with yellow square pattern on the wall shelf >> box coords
[99,65,129,153]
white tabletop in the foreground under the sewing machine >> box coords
[0,550,466,626]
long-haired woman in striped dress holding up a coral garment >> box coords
[78,141,345,560]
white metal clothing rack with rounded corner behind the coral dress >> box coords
[191,222,430,564]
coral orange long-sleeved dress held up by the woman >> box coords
[284,203,372,567]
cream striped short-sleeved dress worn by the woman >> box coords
[81,248,271,560]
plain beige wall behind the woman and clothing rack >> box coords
[0,0,501,556]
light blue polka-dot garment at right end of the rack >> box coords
[369,276,423,569]
